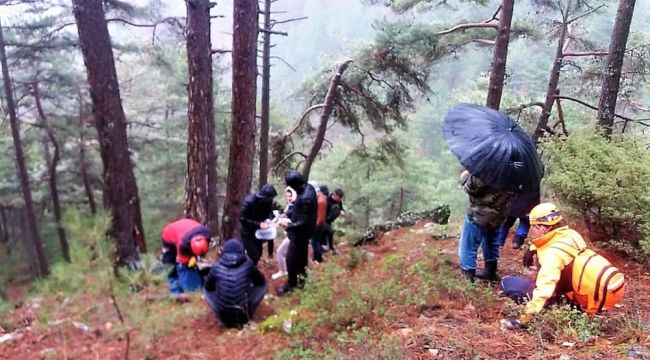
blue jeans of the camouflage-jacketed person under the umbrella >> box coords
[458,215,499,270]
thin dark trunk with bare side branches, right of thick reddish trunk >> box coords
[259,0,271,188]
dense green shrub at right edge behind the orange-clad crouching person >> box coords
[543,129,650,260]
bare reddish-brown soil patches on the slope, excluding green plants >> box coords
[0,223,650,359]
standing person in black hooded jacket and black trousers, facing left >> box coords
[277,170,316,295]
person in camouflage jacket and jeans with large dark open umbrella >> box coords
[443,104,543,282]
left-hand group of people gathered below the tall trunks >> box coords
[161,170,345,327]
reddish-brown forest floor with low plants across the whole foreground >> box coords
[0,222,650,359]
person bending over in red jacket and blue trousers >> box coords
[161,219,210,294]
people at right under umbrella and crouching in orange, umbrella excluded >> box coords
[458,170,625,329]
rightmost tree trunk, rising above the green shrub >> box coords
[598,0,635,137]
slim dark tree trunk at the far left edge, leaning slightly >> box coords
[0,24,49,277]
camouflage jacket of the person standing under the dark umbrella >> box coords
[460,170,513,229]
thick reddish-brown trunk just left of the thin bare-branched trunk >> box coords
[222,0,258,239]
